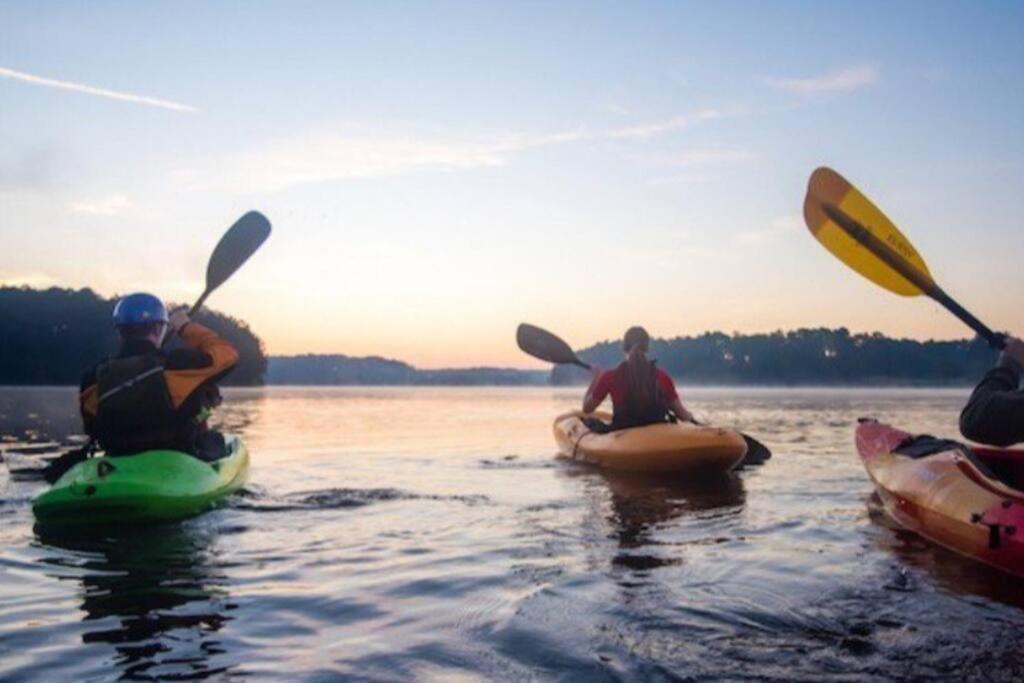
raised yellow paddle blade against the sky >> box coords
[804,167,935,296]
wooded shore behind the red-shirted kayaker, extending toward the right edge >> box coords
[551,328,996,386]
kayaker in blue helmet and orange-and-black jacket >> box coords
[79,293,239,458]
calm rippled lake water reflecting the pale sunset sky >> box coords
[0,388,1024,681]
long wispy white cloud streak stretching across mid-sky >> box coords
[172,110,722,193]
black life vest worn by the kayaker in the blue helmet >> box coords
[95,351,182,456]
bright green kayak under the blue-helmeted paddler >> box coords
[32,436,249,525]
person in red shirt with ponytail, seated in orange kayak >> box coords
[583,327,693,429]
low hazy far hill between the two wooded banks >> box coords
[267,354,550,386]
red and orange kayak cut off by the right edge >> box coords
[856,420,1024,578]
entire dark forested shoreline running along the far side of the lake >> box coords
[0,287,995,386]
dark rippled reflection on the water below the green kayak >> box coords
[38,523,233,680]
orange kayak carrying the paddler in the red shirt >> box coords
[554,412,746,474]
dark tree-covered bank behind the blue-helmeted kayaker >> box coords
[0,287,266,385]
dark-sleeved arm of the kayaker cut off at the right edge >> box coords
[961,338,1024,446]
